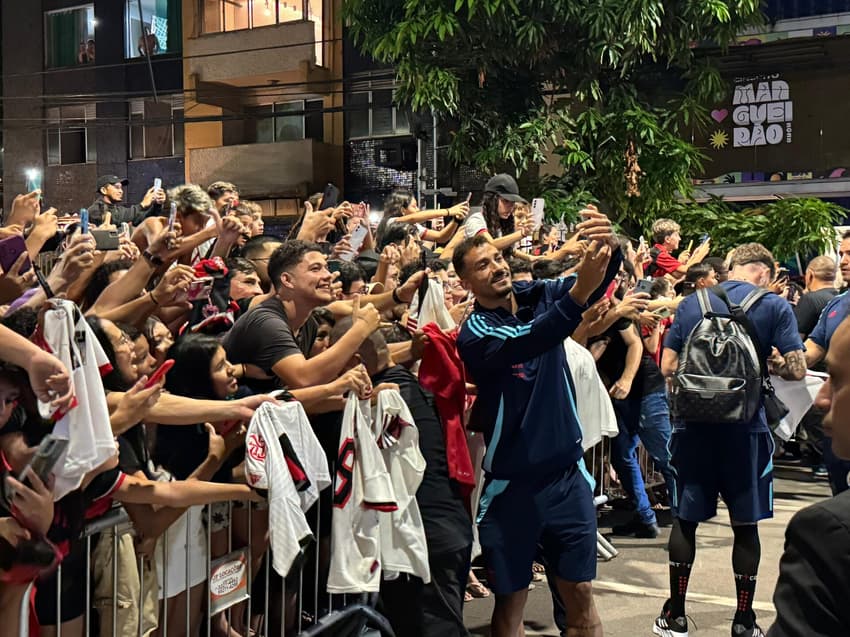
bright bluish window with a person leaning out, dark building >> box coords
[124,0,182,58]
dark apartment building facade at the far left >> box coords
[2,0,185,212]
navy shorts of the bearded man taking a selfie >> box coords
[478,465,596,595]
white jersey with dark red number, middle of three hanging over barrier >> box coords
[328,393,398,593]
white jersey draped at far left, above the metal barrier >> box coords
[38,299,116,500]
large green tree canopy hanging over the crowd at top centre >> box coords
[343,0,762,223]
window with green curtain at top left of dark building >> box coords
[44,4,95,69]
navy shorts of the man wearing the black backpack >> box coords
[670,426,774,524]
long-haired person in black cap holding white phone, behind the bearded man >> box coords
[464,173,534,255]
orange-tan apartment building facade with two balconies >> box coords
[183,0,343,217]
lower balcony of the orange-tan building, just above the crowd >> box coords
[189,139,342,199]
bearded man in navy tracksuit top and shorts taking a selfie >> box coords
[453,209,622,637]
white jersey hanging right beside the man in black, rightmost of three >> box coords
[372,389,431,584]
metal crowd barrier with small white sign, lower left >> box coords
[16,490,394,637]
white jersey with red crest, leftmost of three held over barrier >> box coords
[245,402,330,577]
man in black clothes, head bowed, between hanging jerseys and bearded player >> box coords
[331,319,472,637]
